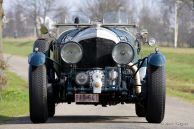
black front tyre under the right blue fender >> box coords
[146,66,166,123]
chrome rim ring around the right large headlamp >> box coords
[112,42,135,65]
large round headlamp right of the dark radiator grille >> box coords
[112,42,134,64]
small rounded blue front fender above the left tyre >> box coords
[28,52,46,66]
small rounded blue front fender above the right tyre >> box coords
[148,52,166,67]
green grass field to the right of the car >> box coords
[142,47,194,103]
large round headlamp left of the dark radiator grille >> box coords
[61,42,83,64]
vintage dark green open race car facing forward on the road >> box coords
[29,15,166,123]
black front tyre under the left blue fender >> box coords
[29,65,48,123]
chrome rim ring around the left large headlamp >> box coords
[60,41,83,64]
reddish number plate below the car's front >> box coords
[75,94,99,103]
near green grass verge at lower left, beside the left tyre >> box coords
[0,72,29,122]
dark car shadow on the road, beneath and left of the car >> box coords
[0,115,146,124]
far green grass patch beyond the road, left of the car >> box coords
[3,38,35,57]
